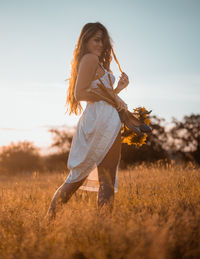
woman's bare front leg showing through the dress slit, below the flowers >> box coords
[97,131,121,212]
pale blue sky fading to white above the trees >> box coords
[0,0,200,149]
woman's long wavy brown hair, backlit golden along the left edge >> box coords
[66,22,122,115]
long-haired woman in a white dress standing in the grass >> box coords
[48,22,129,217]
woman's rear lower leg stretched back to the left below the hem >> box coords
[47,177,87,218]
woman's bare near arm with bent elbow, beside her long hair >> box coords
[74,53,115,102]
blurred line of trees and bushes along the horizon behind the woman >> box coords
[0,114,200,174]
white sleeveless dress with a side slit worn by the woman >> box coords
[65,64,121,191]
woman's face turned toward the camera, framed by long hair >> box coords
[87,30,103,57]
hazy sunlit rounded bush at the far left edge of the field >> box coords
[0,141,43,174]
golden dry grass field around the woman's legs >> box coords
[0,164,200,259]
